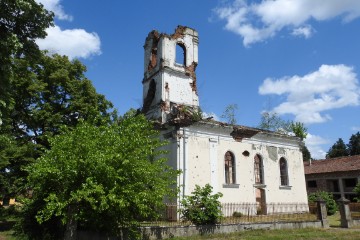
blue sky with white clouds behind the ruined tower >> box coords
[37,0,360,159]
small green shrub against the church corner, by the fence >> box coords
[179,184,222,225]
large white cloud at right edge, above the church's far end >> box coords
[259,65,360,124]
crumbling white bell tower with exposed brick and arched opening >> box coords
[142,26,199,124]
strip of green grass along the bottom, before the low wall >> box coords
[173,228,360,240]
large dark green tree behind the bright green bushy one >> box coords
[0,53,112,195]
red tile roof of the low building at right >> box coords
[304,155,360,175]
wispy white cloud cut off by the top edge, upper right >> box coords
[214,0,360,46]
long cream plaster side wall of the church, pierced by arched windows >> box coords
[176,126,307,204]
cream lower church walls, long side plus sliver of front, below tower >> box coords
[162,124,307,203]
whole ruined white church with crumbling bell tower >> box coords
[142,26,307,214]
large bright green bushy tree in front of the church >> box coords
[18,113,177,239]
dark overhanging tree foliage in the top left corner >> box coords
[0,0,53,122]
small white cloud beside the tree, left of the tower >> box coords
[36,26,101,59]
